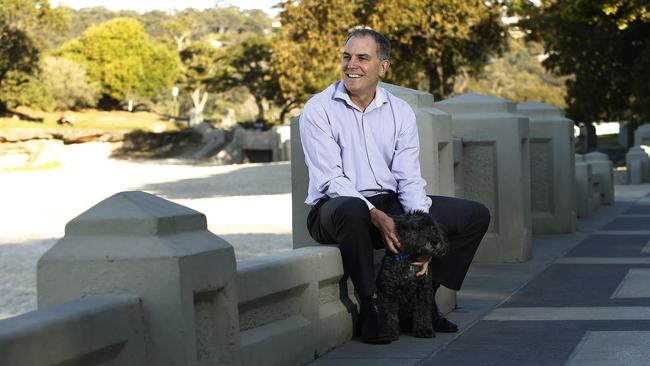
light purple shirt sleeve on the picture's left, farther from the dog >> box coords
[300,102,374,209]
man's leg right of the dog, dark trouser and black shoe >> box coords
[429,196,490,332]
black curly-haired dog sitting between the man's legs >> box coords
[377,211,449,340]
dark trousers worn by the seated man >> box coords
[307,194,490,296]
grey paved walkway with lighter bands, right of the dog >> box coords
[312,185,650,366]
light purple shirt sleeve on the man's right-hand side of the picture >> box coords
[391,108,431,212]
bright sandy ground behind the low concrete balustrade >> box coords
[0,143,292,319]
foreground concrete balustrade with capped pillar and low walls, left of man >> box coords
[0,192,370,366]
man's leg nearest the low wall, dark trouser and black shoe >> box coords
[307,197,391,344]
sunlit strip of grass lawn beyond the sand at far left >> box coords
[0,107,179,132]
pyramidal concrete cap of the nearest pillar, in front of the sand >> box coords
[65,191,207,236]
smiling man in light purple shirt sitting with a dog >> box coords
[300,29,490,344]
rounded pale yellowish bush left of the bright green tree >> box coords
[40,57,99,110]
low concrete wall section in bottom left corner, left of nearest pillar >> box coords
[0,295,147,366]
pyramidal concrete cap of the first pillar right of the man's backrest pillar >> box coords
[435,93,517,113]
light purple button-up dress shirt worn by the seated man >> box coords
[300,80,431,212]
